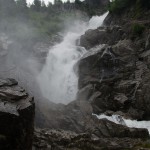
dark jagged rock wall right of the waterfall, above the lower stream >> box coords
[78,22,150,119]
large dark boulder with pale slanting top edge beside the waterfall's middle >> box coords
[78,45,118,89]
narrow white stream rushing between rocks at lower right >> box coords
[94,114,150,134]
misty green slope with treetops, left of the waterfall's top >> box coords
[0,0,108,41]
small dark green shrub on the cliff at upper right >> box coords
[131,23,145,35]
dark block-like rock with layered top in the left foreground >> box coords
[0,79,34,150]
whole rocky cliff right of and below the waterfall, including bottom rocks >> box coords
[34,8,150,150]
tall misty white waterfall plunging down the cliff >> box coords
[38,12,108,104]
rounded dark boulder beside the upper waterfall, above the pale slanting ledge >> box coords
[80,26,125,49]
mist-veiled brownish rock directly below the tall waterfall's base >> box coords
[35,100,94,133]
